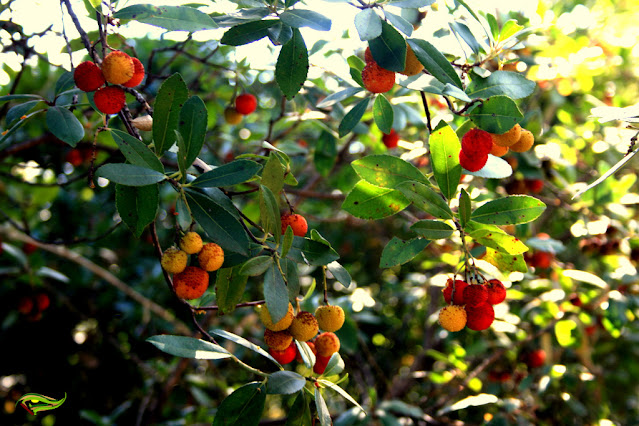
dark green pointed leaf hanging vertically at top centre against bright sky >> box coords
[275,29,308,100]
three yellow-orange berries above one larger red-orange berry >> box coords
[160,231,224,300]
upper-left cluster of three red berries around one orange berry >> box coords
[73,50,144,114]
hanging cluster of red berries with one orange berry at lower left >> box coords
[439,279,506,331]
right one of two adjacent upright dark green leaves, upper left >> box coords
[178,96,208,169]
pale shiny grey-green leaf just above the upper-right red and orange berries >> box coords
[466,71,537,99]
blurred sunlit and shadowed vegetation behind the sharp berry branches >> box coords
[0,0,639,425]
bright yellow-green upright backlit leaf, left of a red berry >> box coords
[429,125,461,200]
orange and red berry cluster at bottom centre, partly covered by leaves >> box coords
[259,303,345,374]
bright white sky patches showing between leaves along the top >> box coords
[0,0,537,87]
